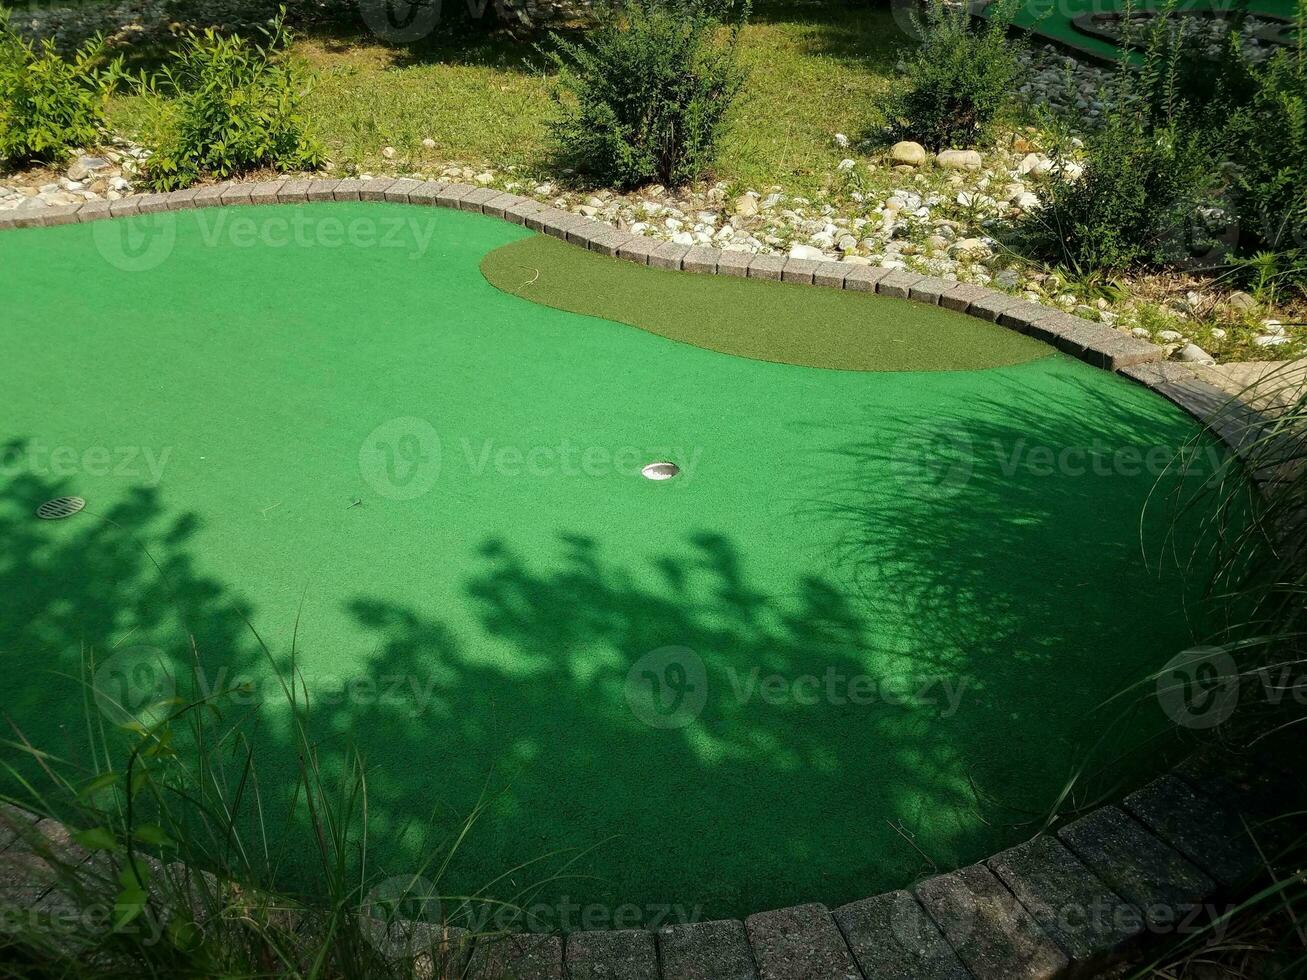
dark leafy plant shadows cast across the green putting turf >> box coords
[0,365,1244,928]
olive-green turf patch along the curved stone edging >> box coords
[481,235,1052,371]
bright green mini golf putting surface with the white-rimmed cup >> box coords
[0,203,1219,928]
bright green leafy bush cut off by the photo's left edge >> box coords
[0,8,110,165]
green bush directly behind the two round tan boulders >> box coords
[878,0,1018,150]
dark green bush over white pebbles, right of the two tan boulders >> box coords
[1016,112,1214,274]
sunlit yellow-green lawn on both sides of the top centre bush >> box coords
[111,0,908,195]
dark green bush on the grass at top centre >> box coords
[545,0,748,188]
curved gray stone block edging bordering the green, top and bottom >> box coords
[0,178,1273,980]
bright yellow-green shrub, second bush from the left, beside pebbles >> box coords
[144,16,322,191]
